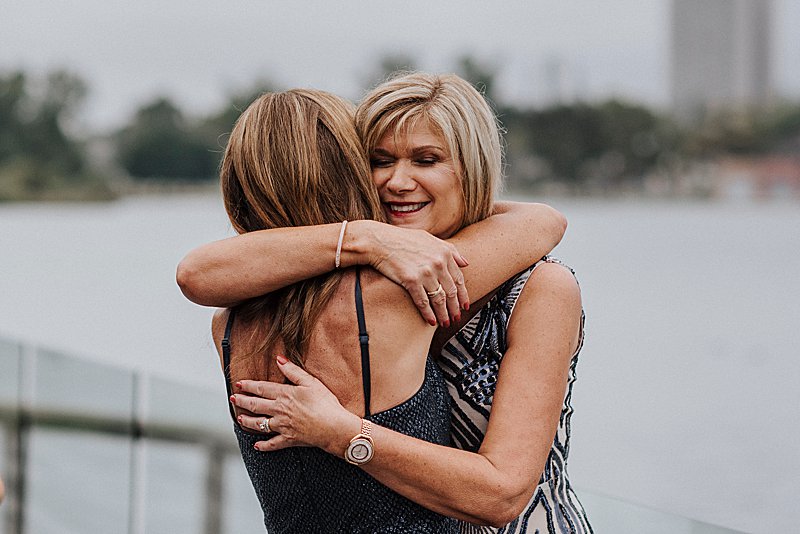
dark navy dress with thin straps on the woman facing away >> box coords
[222,271,458,534]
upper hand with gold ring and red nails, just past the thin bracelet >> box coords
[370,224,469,328]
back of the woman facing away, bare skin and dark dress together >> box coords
[219,270,455,533]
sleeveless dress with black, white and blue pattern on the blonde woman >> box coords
[437,257,593,534]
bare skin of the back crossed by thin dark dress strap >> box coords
[212,268,435,415]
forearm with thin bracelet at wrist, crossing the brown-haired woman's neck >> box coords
[176,221,380,307]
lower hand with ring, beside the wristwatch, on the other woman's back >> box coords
[231,356,361,455]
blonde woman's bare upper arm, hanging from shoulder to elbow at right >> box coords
[480,263,581,502]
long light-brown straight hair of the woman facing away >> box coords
[220,89,383,372]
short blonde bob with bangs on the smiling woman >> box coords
[356,72,503,227]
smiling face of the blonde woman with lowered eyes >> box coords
[370,120,464,239]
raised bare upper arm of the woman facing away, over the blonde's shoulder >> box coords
[448,202,566,300]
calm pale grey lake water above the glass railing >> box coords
[0,196,800,533]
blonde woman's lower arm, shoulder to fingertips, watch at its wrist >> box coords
[235,264,581,526]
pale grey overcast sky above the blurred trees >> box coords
[0,0,800,128]
